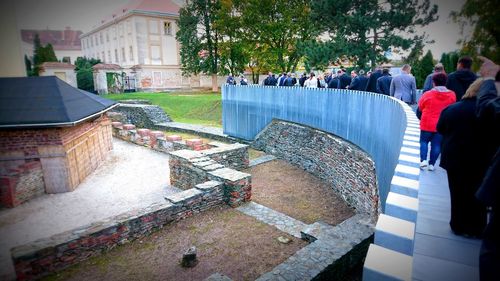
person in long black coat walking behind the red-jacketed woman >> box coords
[437,79,495,237]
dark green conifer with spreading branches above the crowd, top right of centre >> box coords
[312,0,438,68]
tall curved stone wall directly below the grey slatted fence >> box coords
[252,120,380,216]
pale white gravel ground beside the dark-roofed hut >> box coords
[0,139,178,280]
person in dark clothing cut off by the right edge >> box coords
[476,57,500,281]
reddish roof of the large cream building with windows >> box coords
[80,0,180,37]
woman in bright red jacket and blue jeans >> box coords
[418,73,456,171]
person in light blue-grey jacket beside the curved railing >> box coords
[390,64,416,105]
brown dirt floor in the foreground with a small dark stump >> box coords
[42,207,307,281]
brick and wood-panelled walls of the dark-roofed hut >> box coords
[0,115,112,207]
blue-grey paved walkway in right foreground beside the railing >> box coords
[412,165,481,281]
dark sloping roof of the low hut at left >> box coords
[0,76,116,128]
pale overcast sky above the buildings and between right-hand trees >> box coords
[16,0,465,59]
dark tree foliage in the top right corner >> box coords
[451,0,500,66]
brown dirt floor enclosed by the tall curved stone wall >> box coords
[245,160,354,225]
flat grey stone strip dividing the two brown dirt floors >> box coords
[237,202,307,238]
